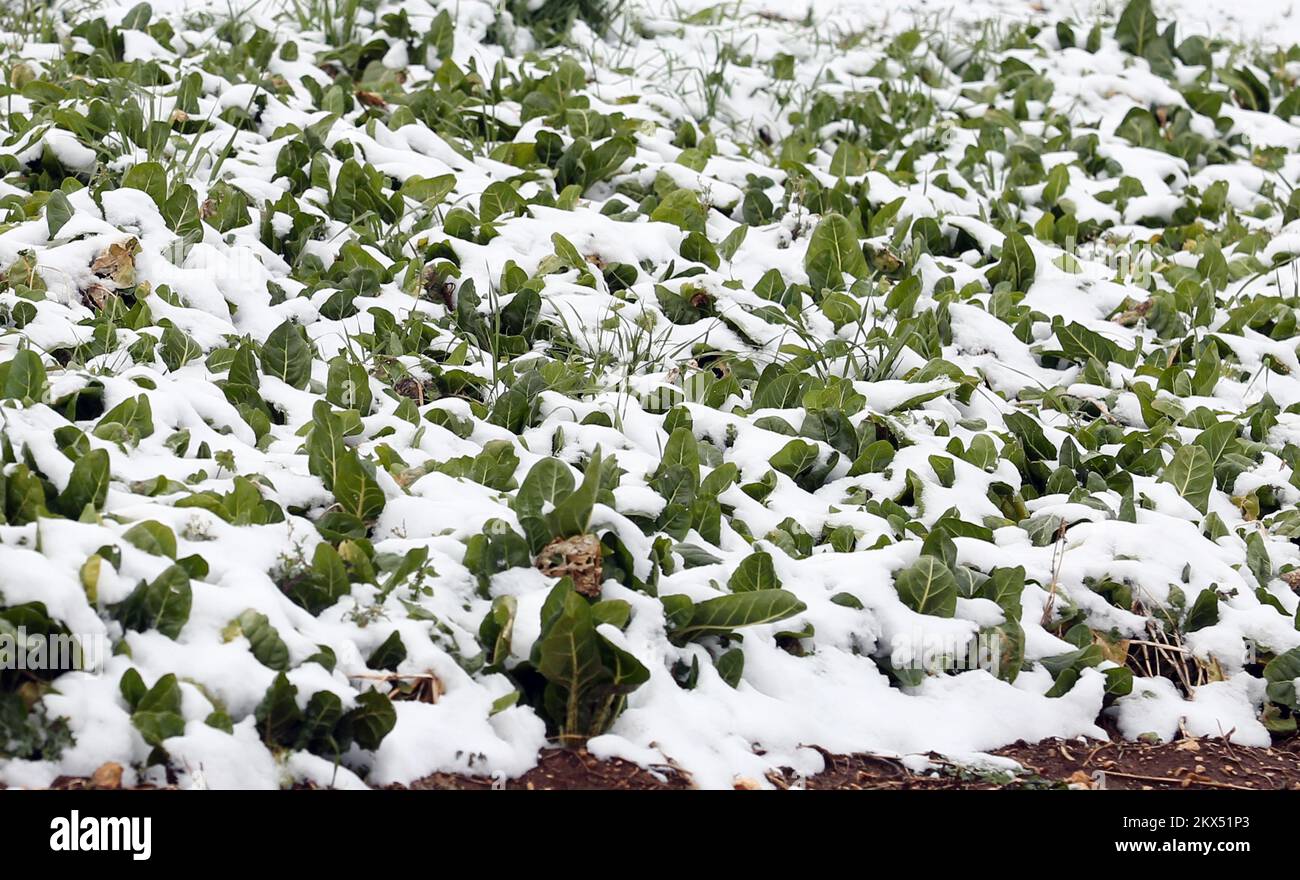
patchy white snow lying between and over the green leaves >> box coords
[0,0,1300,789]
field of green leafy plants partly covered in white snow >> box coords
[0,0,1300,788]
